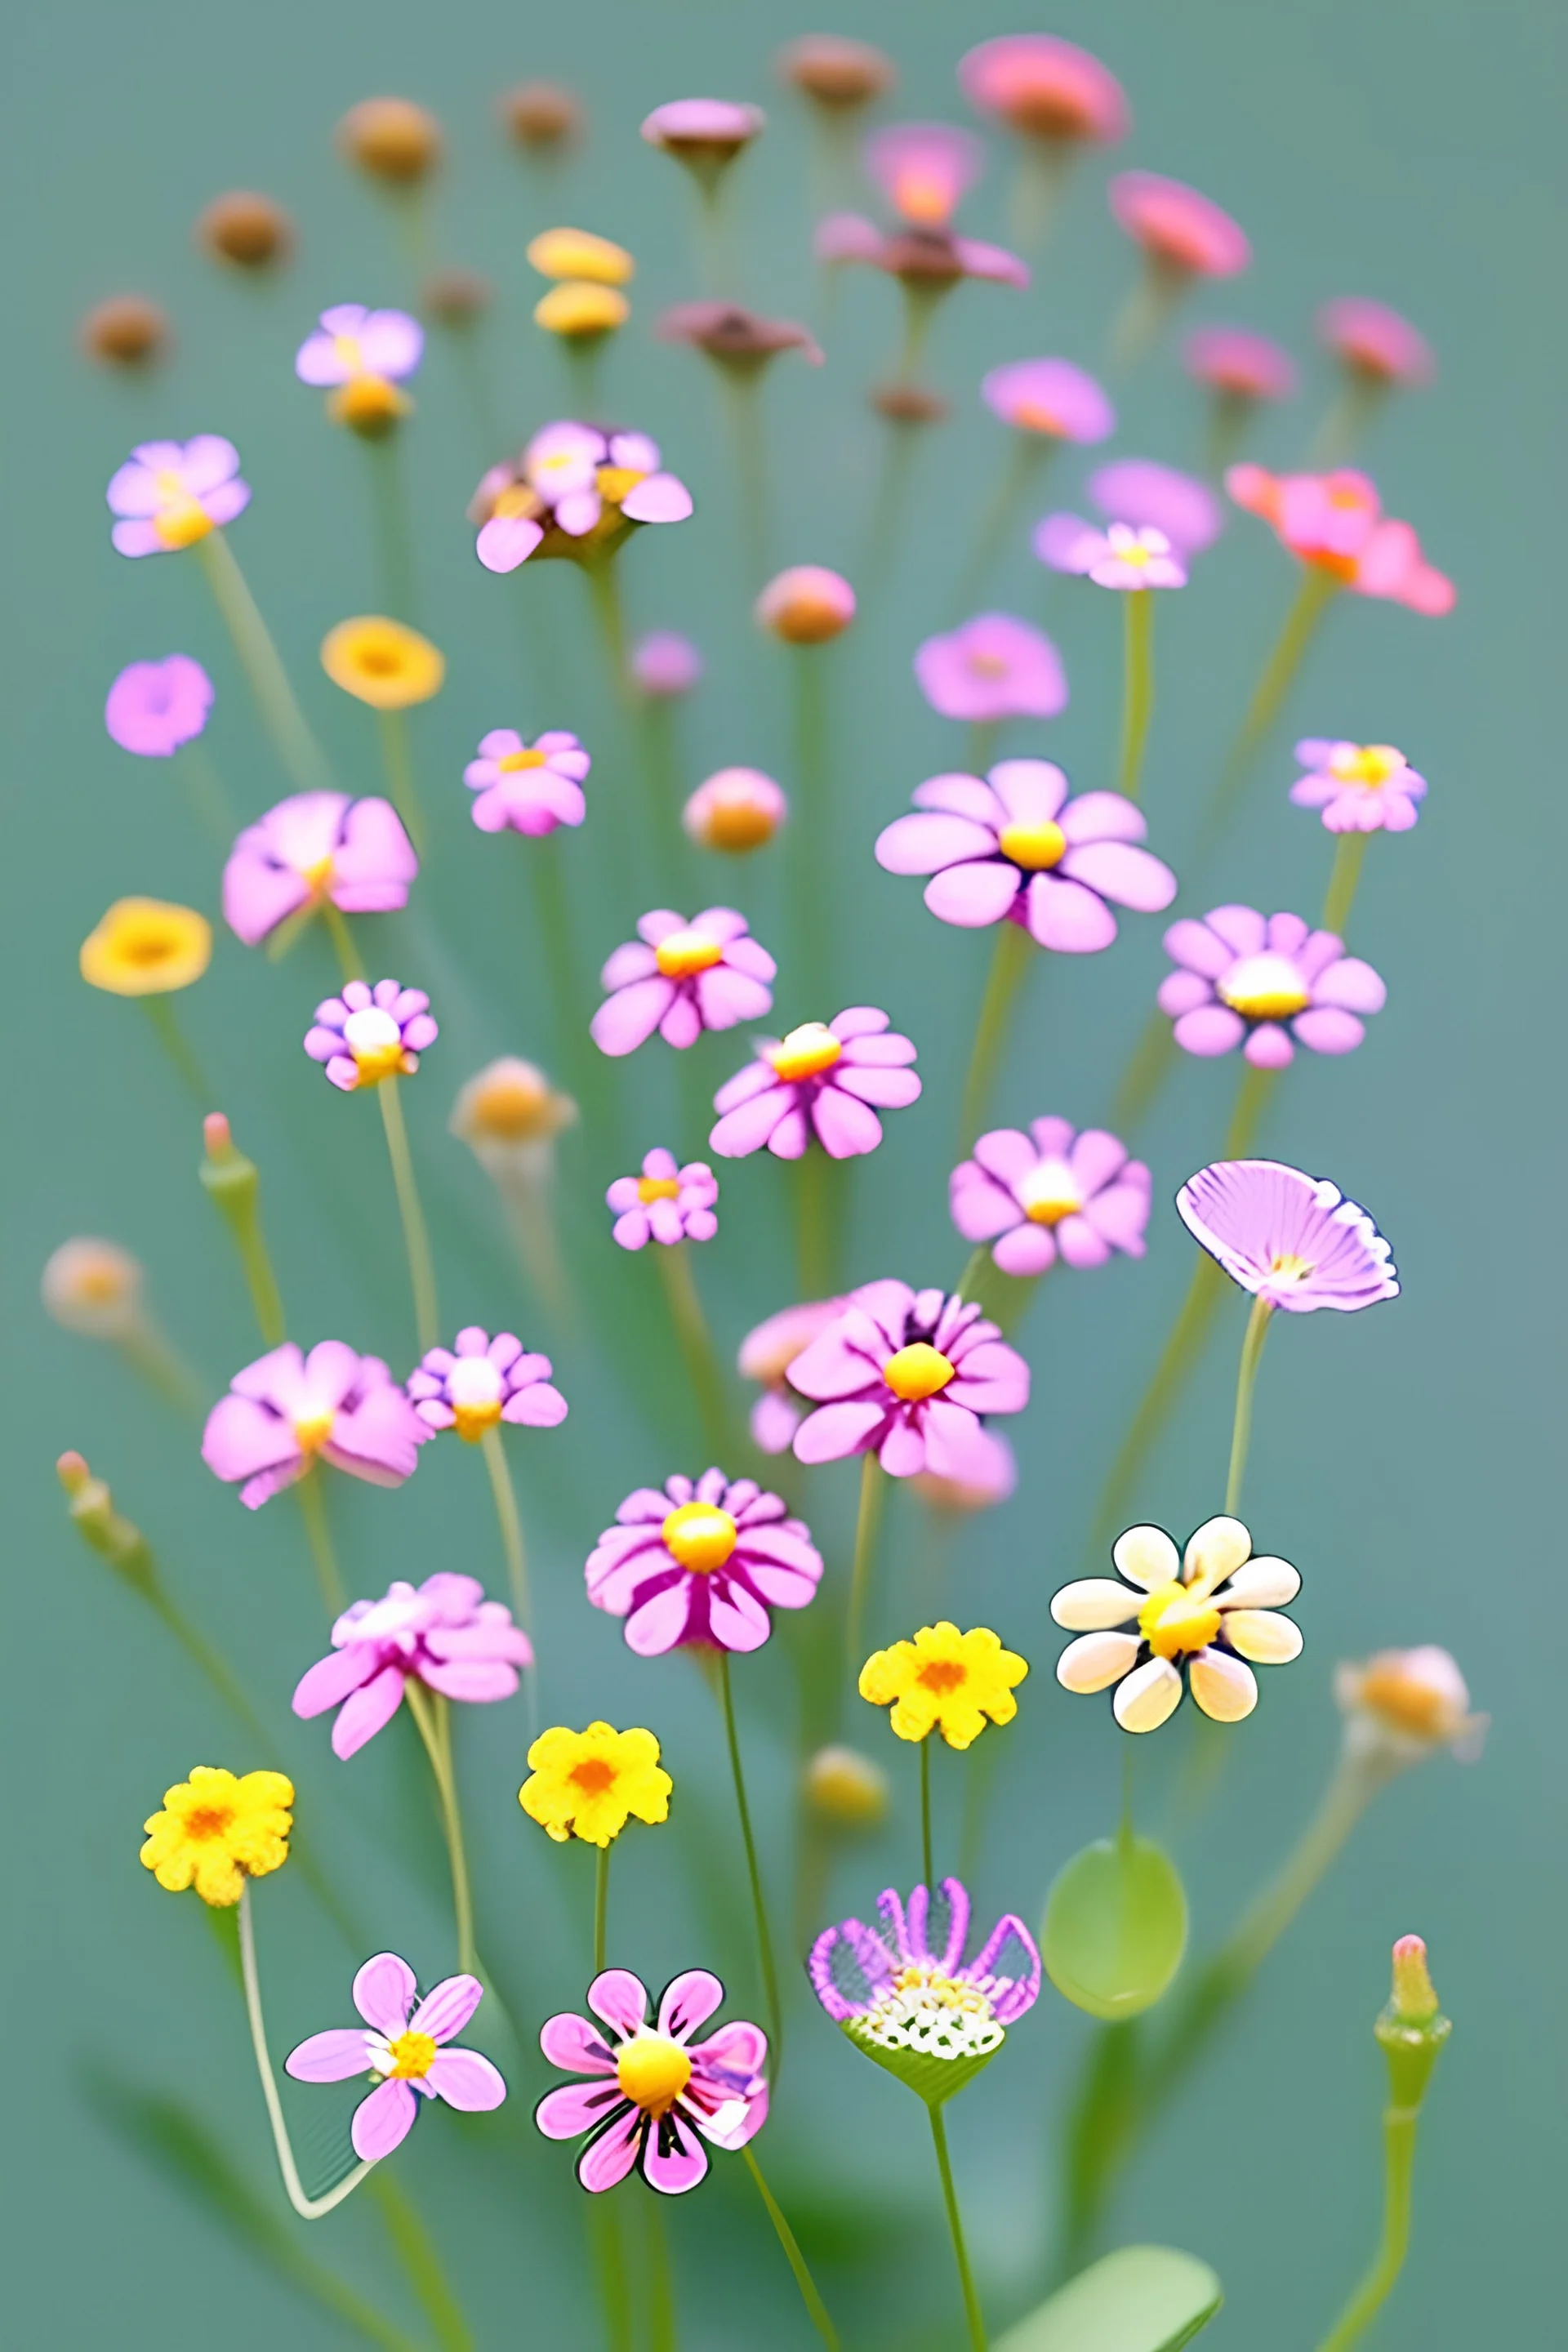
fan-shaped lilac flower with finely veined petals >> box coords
[1175,1160,1399,1315]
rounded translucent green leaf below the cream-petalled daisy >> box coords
[1039,1837,1187,2023]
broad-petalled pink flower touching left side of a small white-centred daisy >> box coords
[203,1339,430,1510]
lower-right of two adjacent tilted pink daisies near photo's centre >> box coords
[707,1004,920,1160]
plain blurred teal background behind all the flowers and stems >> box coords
[0,0,1568,2352]
